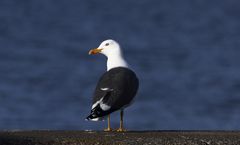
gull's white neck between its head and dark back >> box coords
[107,54,128,71]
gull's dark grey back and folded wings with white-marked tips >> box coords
[87,67,138,119]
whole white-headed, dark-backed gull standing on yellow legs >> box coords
[86,39,139,132]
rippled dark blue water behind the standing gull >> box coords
[0,0,240,130]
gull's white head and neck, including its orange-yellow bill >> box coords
[89,39,128,70]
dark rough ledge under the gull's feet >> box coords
[0,131,240,145]
